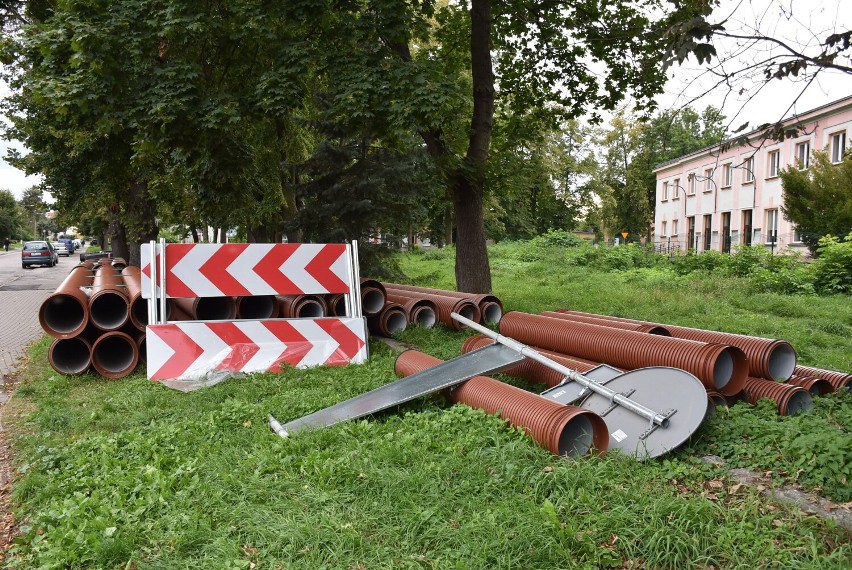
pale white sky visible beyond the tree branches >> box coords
[0,0,852,198]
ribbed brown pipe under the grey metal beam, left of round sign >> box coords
[394,350,609,457]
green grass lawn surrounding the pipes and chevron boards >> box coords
[4,241,852,569]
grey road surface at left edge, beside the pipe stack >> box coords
[0,248,80,384]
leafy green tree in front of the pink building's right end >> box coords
[781,152,852,253]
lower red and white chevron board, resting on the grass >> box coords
[147,318,367,380]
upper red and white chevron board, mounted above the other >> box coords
[142,243,352,299]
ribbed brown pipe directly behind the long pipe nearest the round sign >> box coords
[556,309,796,380]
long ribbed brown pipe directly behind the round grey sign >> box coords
[500,311,748,395]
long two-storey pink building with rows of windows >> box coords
[654,96,852,252]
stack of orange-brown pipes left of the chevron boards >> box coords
[39,259,139,378]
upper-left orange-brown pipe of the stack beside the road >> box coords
[38,264,94,338]
